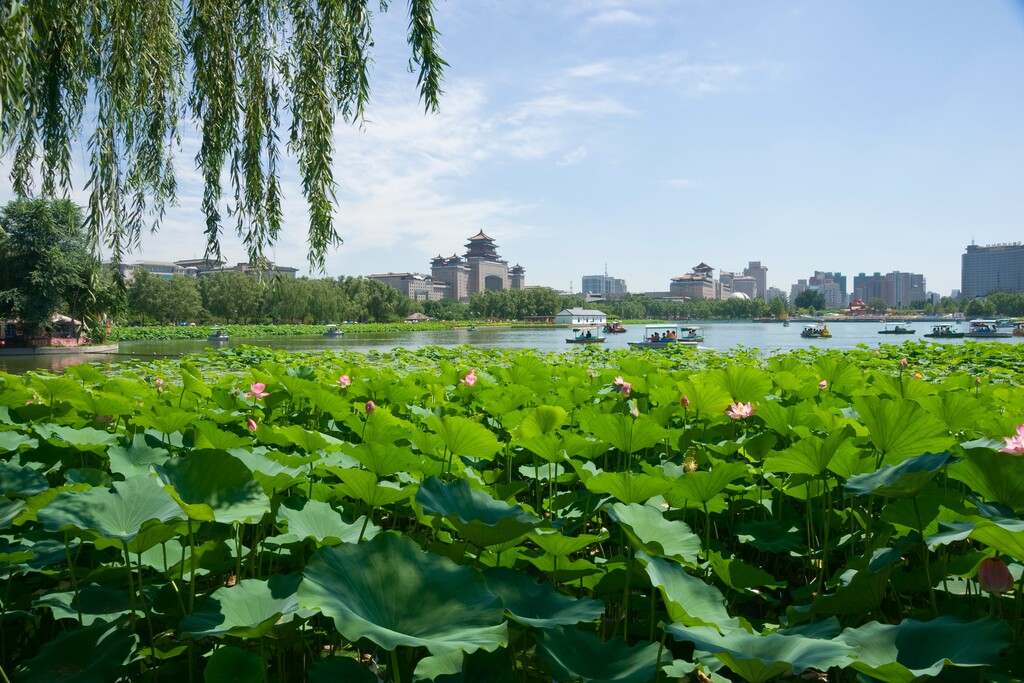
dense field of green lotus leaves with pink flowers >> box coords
[0,344,1024,683]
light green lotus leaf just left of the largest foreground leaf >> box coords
[178,573,301,639]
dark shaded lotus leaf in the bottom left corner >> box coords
[14,620,138,683]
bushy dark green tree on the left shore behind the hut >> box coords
[0,200,100,335]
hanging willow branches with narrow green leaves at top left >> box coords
[0,0,445,267]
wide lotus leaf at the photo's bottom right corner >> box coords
[838,616,1013,683]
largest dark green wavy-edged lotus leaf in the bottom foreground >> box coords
[298,533,508,654]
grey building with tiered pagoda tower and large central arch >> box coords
[430,230,526,301]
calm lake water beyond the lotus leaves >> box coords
[0,322,1024,373]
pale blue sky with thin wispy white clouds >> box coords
[0,0,1024,295]
